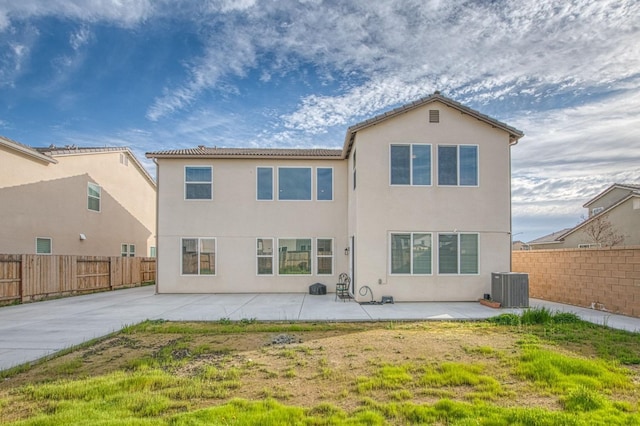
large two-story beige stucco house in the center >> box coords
[147,92,523,301]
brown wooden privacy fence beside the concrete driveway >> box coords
[0,254,156,303]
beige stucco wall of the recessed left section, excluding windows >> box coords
[157,159,348,293]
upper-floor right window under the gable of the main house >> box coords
[438,145,478,186]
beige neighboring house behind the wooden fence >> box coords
[0,137,156,256]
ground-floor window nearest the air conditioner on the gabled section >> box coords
[438,234,479,275]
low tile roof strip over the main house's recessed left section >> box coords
[146,146,342,159]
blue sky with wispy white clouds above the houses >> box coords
[0,0,640,241]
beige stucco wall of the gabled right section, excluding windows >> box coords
[348,103,511,301]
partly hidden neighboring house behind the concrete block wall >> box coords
[528,183,640,249]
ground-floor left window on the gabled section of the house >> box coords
[391,232,432,275]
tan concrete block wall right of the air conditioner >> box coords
[511,246,640,317]
